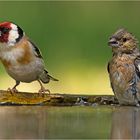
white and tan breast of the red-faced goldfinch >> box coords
[0,41,34,68]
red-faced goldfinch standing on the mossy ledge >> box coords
[0,22,58,93]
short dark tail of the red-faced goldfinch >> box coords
[39,70,58,83]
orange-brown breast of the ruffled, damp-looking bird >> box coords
[109,57,135,87]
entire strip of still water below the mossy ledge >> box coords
[0,106,140,139]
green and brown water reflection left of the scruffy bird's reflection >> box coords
[0,106,112,139]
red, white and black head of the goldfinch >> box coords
[0,22,24,47]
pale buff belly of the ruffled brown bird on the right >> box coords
[110,65,136,104]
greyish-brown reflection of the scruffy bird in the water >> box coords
[111,107,140,139]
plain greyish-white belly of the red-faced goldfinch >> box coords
[7,59,44,83]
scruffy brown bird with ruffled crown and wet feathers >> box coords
[108,29,140,106]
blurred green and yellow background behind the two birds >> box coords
[0,1,140,94]
